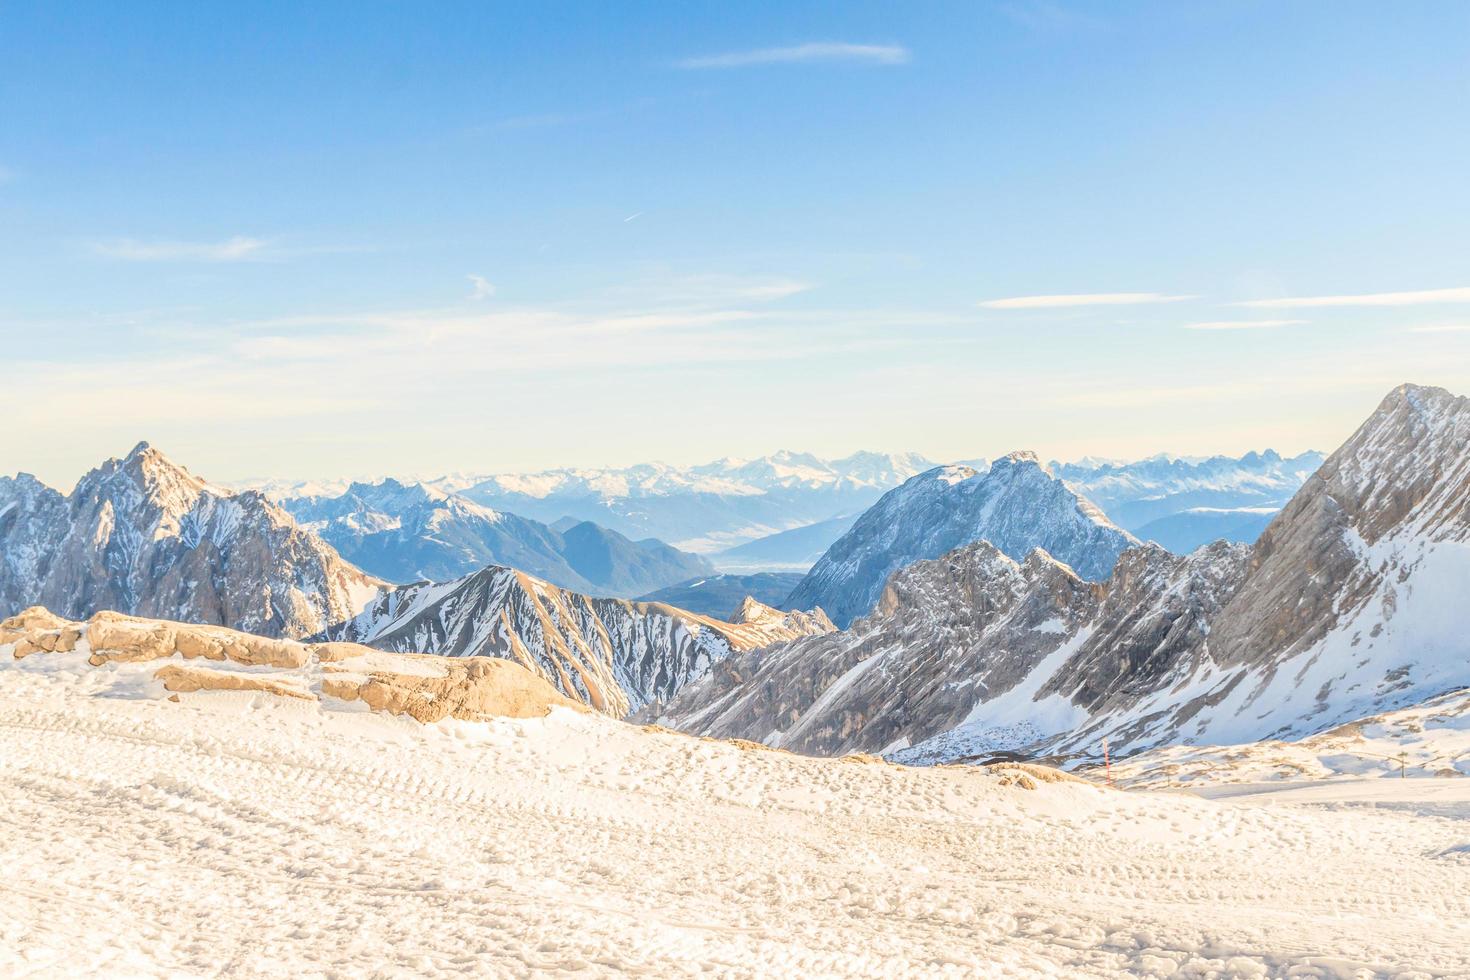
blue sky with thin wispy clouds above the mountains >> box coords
[0,0,1470,486]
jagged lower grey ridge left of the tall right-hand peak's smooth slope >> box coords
[639,541,1245,761]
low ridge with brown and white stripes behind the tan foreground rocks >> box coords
[323,566,833,717]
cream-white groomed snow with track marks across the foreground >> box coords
[0,649,1470,977]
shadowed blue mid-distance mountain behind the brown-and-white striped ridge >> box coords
[282,479,713,595]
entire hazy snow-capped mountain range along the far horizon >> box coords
[238,450,1322,575]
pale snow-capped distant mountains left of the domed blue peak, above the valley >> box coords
[434,451,932,552]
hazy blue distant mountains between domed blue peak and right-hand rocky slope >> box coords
[1047,450,1323,554]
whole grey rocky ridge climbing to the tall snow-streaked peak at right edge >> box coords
[645,385,1470,763]
